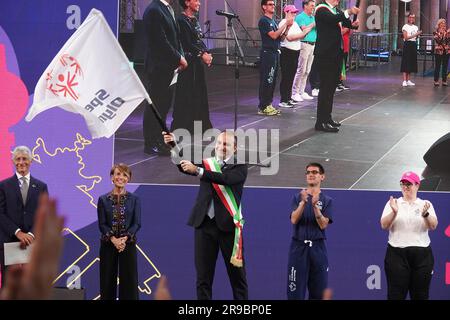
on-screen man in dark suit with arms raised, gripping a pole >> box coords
[314,0,359,132]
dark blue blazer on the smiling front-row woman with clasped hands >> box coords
[97,192,141,240]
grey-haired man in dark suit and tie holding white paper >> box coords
[0,146,48,287]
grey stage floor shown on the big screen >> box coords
[114,58,450,191]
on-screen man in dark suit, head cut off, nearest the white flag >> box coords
[143,0,187,154]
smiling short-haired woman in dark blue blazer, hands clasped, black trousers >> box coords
[97,163,141,300]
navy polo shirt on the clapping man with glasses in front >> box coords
[292,192,333,241]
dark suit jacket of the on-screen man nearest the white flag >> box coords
[143,0,183,73]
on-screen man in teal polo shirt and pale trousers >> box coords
[291,0,317,102]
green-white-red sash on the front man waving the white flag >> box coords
[203,158,244,267]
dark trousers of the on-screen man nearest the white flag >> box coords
[143,67,173,148]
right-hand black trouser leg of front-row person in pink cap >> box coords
[408,247,434,300]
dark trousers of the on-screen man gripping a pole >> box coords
[314,55,342,123]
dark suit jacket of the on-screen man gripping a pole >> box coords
[314,8,352,60]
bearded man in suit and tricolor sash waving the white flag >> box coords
[164,132,248,300]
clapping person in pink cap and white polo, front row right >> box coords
[380,171,438,300]
